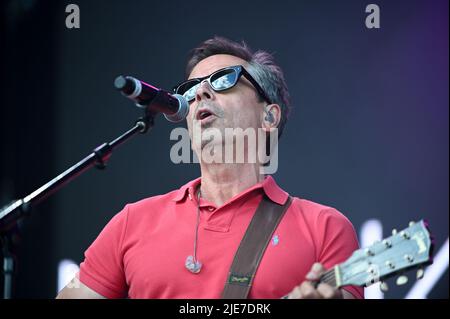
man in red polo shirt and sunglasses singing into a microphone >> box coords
[58,37,363,299]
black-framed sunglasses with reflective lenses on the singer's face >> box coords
[173,65,272,104]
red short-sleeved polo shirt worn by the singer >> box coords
[80,176,363,299]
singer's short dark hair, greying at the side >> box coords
[186,36,291,137]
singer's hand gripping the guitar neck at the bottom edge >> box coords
[287,263,354,299]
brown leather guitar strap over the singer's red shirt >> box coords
[222,195,292,299]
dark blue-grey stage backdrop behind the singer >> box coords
[0,0,449,298]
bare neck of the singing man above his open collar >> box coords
[200,164,264,206]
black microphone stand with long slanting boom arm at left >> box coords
[0,108,156,299]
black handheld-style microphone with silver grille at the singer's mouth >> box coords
[114,75,189,123]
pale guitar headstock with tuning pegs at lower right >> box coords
[338,220,433,287]
